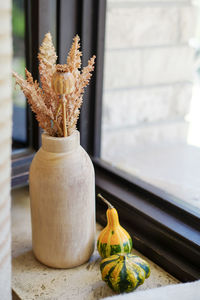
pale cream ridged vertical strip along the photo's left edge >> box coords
[0,0,12,300]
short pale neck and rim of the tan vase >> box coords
[42,130,80,153]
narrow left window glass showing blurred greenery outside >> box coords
[12,0,27,149]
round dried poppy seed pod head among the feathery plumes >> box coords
[51,69,75,95]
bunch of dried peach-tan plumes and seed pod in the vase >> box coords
[13,33,95,137]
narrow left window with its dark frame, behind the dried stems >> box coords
[12,0,57,187]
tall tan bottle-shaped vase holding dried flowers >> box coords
[29,131,95,268]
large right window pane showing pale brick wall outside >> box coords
[101,0,200,212]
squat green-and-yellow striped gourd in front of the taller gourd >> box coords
[100,253,150,293]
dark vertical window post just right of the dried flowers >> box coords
[79,0,106,157]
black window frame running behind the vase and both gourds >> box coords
[12,0,200,282]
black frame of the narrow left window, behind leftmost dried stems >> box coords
[11,0,58,188]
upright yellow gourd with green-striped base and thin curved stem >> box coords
[97,194,132,258]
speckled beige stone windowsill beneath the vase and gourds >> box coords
[12,188,179,300]
